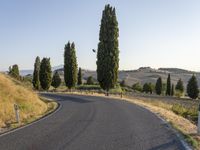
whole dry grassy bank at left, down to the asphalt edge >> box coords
[0,73,57,132]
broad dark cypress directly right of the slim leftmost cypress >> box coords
[39,58,52,90]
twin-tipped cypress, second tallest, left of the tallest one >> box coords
[64,42,78,89]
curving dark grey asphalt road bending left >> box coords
[0,94,184,150]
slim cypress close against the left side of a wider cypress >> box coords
[32,56,40,90]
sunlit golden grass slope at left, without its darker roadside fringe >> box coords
[0,73,47,128]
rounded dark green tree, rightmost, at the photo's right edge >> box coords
[187,75,199,99]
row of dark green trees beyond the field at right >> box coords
[130,74,199,99]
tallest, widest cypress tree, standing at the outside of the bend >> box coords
[97,5,119,92]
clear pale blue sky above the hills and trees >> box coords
[0,0,200,71]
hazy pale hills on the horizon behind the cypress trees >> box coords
[18,65,200,87]
